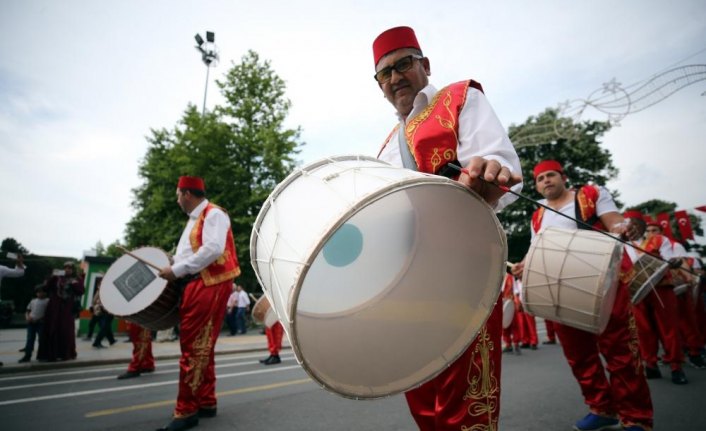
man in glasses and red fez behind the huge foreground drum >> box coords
[373,27,522,430]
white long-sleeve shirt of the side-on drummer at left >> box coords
[172,199,230,278]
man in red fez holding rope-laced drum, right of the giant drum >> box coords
[513,160,653,431]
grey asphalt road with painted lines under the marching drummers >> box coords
[0,338,706,431]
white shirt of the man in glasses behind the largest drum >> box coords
[378,84,522,212]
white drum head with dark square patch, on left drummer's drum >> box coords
[100,247,169,316]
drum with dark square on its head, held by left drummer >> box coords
[100,247,179,331]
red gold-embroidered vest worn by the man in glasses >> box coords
[378,80,483,174]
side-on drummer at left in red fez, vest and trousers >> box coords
[159,176,240,430]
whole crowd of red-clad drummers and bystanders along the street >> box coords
[1,27,706,431]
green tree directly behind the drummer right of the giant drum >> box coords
[498,109,619,262]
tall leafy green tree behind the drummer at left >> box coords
[126,51,303,291]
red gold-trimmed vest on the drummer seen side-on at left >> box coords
[189,202,240,286]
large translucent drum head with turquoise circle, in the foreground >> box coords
[289,177,507,398]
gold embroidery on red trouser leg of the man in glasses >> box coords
[461,325,500,431]
